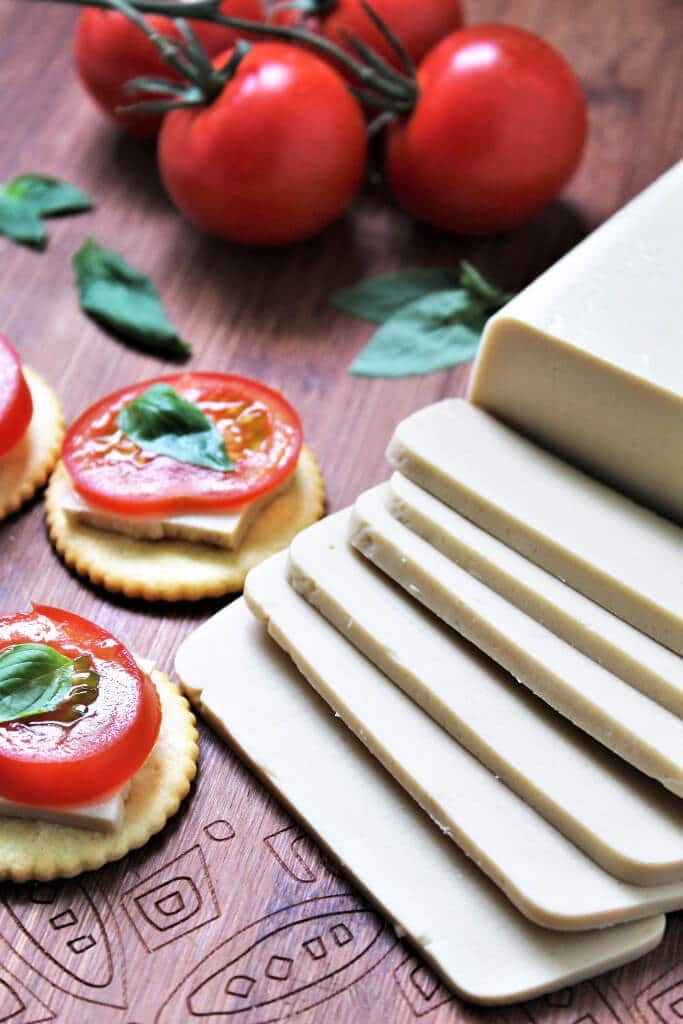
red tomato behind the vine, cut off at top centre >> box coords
[273,0,463,69]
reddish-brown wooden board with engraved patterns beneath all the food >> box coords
[0,0,683,1024]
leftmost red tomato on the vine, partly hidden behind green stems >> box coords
[74,0,263,138]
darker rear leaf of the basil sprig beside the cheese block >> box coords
[332,268,457,324]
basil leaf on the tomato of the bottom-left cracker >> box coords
[0,643,99,722]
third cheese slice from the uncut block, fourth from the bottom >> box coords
[350,485,683,798]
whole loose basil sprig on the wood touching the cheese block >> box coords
[332,261,512,377]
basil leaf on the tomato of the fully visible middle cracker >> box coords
[117,384,234,472]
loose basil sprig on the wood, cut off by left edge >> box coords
[0,174,92,249]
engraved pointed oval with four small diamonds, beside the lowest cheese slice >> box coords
[158,894,396,1024]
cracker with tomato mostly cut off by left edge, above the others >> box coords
[0,335,63,519]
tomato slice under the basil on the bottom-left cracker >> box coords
[0,605,161,807]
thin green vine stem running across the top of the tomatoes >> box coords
[34,0,418,116]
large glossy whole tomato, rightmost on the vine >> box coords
[386,25,587,233]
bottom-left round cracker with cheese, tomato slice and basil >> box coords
[0,605,199,882]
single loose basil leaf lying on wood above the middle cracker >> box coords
[73,239,190,357]
